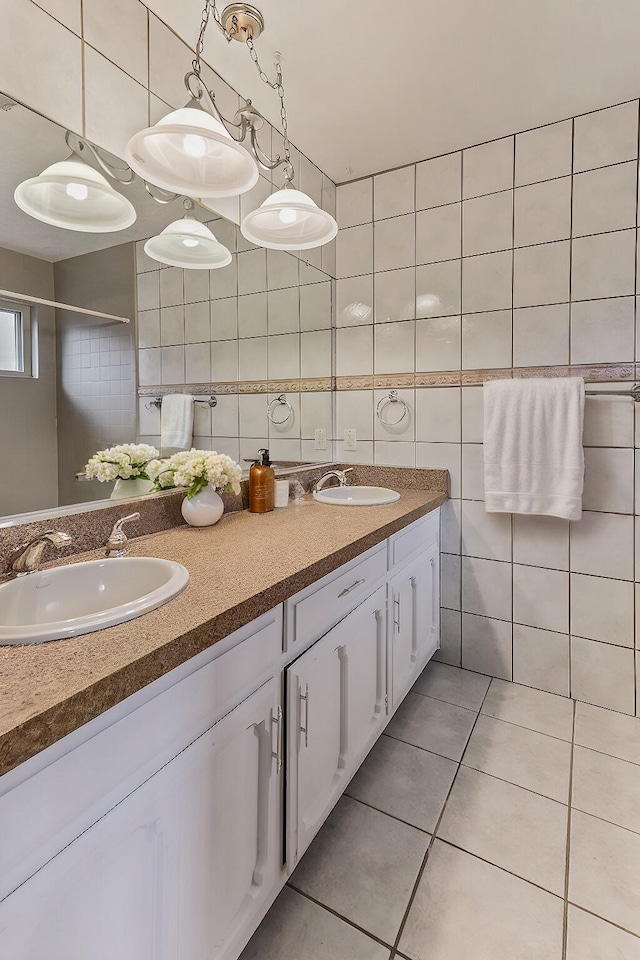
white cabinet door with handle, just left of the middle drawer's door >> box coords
[175,677,283,960]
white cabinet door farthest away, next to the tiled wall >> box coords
[388,542,440,708]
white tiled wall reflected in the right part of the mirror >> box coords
[137,220,336,461]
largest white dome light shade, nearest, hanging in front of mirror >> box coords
[125,107,258,197]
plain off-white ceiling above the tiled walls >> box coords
[145,0,640,183]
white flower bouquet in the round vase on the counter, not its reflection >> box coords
[147,449,242,499]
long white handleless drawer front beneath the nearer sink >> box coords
[0,607,282,899]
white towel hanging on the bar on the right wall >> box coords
[483,377,584,520]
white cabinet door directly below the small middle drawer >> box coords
[287,588,386,862]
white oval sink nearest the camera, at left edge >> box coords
[0,557,189,646]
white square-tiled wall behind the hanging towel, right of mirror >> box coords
[336,95,640,714]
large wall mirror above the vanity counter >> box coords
[0,94,333,518]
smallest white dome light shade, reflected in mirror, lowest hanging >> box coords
[144,217,231,270]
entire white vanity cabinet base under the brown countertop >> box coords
[0,508,439,960]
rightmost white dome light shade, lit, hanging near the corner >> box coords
[240,188,338,250]
